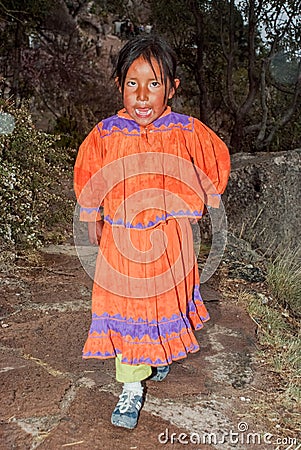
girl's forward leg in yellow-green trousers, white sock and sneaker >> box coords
[111,355,152,429]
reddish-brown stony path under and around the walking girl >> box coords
[0,246,296,450]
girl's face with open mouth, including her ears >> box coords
[117,57,180,127]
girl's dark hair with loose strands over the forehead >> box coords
[113,35,177,102]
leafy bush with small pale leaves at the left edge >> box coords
[0,102,73,249]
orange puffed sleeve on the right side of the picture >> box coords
[192,119,230,207]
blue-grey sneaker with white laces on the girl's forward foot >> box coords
[111,391,143,430]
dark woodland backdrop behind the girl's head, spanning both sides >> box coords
[0,0,301,153]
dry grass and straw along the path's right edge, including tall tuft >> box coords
[216,244,301,438]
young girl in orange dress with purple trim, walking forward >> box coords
[74,35,230,429]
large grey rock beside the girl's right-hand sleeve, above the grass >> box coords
[223,149,301,254]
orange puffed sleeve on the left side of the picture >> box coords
[74,124,104,222]
